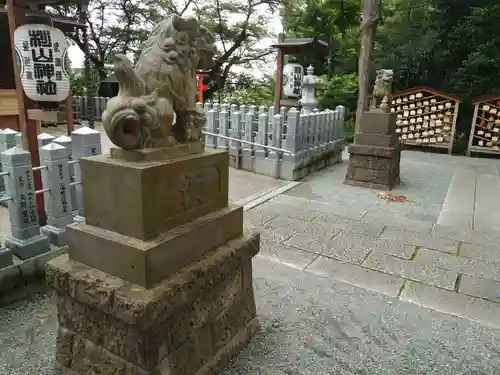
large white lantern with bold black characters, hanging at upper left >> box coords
[14,24,70,102]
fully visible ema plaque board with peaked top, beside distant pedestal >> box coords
[391,87,460,154]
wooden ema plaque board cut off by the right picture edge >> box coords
[467,96,500,156]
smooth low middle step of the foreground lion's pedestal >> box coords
[66,205,243,288]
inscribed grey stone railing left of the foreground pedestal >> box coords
[0,127,101,268]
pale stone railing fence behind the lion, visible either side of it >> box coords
[54,96,346,180]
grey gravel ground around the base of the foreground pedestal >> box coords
[0,257,500,375]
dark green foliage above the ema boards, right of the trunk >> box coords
[376,0,500,100]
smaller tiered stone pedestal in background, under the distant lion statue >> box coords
[345,110,401,190]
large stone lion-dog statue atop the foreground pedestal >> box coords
[102,16,216,150]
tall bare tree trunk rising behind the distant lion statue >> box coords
[355,0,382,134]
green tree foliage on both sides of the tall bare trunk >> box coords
[282,0,500,114]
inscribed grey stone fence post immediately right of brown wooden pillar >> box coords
[40,142,73,246]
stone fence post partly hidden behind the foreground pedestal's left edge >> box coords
[71,126,102,220]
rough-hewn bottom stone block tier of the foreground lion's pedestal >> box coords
[46,230,259,375]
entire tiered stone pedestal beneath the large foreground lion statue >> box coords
[47,145,259,375]
